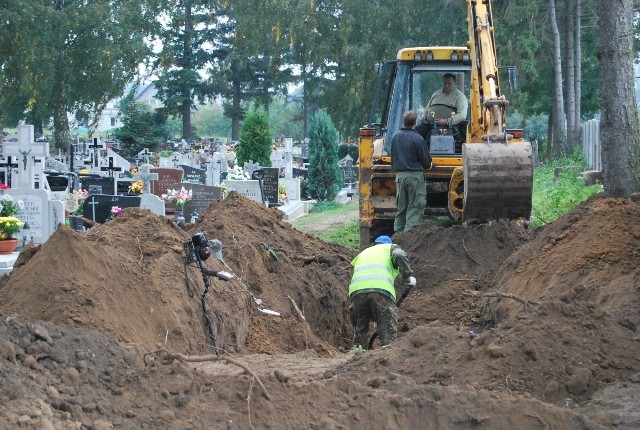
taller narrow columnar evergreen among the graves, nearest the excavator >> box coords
[308,109,342,201]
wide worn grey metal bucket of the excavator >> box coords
[462,142,533,221]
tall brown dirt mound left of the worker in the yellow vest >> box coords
[0,193,351,354]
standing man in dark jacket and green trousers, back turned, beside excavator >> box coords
[391,110,431,232]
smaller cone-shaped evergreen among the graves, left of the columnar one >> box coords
[237,108,273,167]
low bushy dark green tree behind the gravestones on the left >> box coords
[113,89,166,156]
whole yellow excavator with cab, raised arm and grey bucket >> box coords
[358,0,533,248]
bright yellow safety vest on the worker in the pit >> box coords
[349,244,398,300]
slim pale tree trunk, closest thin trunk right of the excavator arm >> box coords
[549,0,569,157]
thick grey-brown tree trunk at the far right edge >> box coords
[597,0,640,197]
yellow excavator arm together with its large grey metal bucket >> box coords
[460,0,533,221]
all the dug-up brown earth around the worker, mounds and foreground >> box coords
[0,193,640,429]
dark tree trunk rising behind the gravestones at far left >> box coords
[53,0,69,149]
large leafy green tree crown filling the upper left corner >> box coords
[0,0,158,148]
